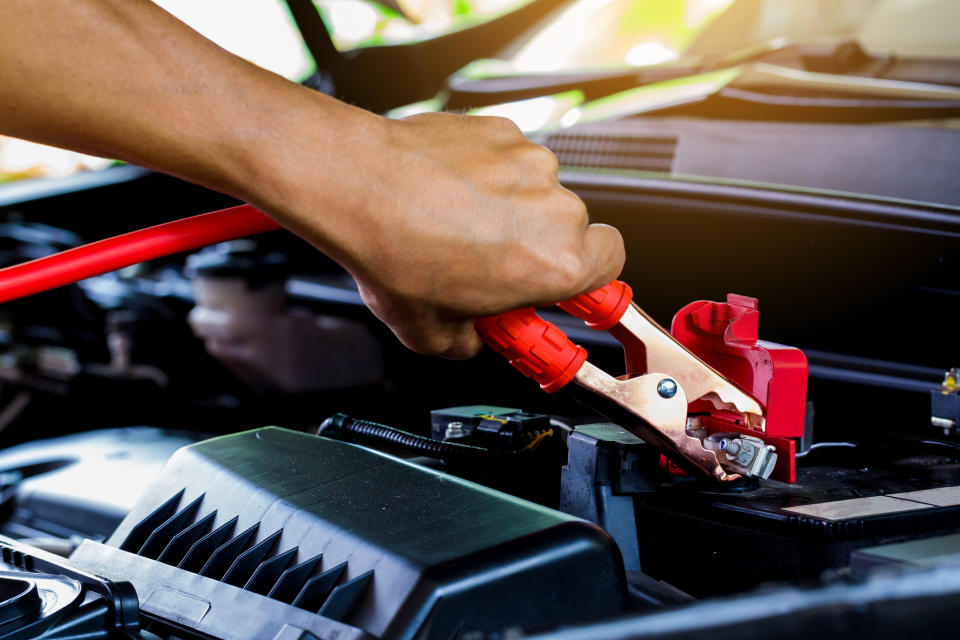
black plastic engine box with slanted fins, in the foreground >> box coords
[71,428,625,640]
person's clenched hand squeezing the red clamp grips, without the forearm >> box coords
[276,114,624,358]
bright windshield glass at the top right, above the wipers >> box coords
[512,0,960,72]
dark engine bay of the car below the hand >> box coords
[0,161,960,640]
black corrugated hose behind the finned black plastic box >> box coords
[317,413,529,462]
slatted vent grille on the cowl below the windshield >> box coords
[544,131,677,173]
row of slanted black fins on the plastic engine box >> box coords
[120,491,373,621]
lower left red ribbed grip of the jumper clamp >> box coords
[475,307,587,393]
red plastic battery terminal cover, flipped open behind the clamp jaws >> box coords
[670,294,808,482]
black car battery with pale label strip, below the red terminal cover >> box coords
[634,455,960,596]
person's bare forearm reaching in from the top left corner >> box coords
[0,0,376,245]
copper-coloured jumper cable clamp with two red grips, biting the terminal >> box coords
[476,281,806,481]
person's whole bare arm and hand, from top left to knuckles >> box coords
[0,0,624,358]
